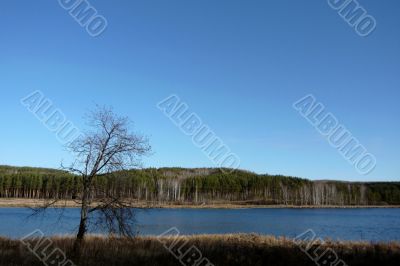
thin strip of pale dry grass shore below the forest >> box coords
[0,198,400,209]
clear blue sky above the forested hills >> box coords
[0,0,400,181]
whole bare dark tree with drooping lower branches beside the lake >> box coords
[63,107,151,242]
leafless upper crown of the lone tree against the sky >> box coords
[68,107,151,177]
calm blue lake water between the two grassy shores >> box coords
[0,208,400,241]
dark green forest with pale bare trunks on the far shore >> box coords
[0,166,400,206]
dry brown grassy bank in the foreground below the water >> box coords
[0,235,400,266]
